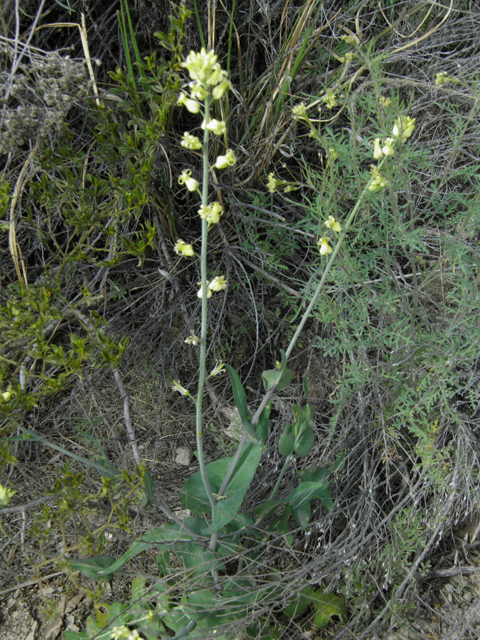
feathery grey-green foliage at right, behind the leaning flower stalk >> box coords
[288,87,480,487]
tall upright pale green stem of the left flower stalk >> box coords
[196,98,216,518]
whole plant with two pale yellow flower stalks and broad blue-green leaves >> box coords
[65,49,414,638]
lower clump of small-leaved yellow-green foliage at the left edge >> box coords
[0,282,128,440]
